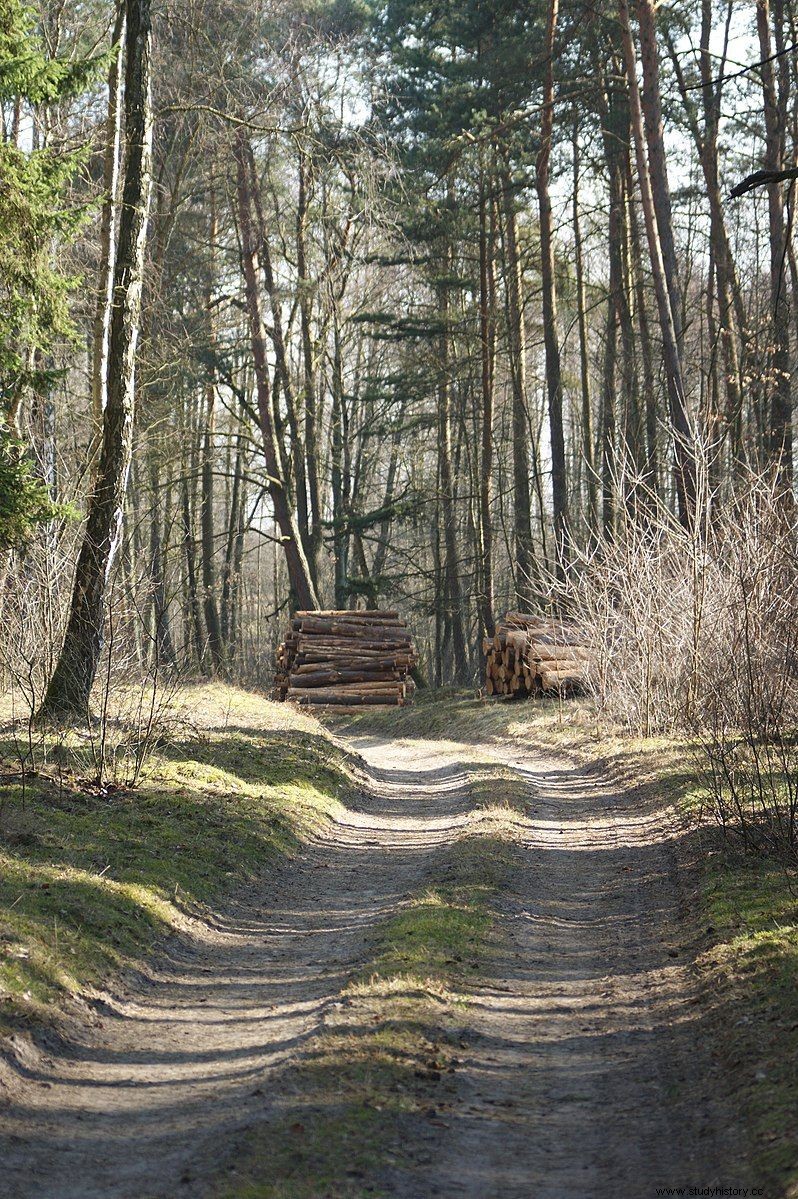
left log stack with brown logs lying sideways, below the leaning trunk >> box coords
[274,610,417,707]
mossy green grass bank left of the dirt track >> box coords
[0,686,351,1034]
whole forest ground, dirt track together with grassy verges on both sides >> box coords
[0,698,798,1199]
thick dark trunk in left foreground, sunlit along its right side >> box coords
[42,0,152,717]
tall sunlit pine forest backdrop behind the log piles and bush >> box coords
[2,2,798,707]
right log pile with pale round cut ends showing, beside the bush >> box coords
[482,611,591,699]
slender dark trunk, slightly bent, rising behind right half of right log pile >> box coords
[536,0,569,577]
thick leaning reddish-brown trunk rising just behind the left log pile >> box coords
[234,129,319,609]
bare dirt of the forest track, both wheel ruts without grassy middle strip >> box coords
[0,736,740,1199]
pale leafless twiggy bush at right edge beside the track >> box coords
[564,477,798,854]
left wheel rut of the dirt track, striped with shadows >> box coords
[0,733,470,1199]
